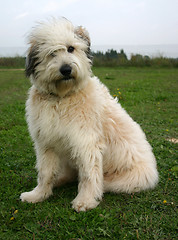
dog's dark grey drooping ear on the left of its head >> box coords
[25,44,39,77]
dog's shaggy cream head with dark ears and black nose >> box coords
[26,18,91,96]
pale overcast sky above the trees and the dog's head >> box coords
[0,0,178,47]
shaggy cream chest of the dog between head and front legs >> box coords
[26,90,91,151]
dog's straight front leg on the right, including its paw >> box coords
[72,148,103,212]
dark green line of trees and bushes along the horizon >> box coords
[0,49,178,68]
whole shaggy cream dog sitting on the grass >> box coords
[20,18,158,212]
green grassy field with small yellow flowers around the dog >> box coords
[0,68,178,240]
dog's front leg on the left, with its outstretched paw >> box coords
[20,149,59,203]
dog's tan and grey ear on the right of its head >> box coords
[75,26,93,63]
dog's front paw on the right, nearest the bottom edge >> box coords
[71,197,99,212]
